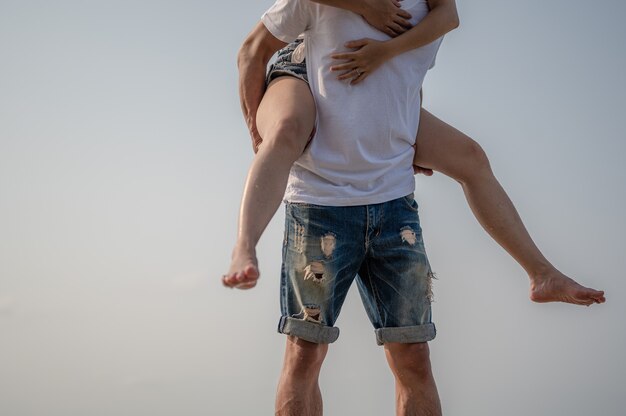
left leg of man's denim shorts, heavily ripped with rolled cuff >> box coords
[279,203,366,343]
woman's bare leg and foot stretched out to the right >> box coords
[414,109,605,305]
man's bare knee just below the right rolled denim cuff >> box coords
[385,342,432,378]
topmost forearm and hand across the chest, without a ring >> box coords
[311,0,411,37]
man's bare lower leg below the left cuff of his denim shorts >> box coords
[276,336,328,416]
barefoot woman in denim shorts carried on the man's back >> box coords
[222,0,604,305]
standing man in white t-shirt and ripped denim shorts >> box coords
[234,0,441,415]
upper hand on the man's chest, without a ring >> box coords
[358,0,411,38]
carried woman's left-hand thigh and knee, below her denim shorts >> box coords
[256,76,315,143]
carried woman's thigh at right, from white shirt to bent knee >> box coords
[413,109,489,180]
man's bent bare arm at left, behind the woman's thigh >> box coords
[237,22,287,153]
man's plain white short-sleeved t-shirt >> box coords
[262,0,441,206]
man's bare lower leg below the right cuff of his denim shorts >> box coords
[385,342,441,416]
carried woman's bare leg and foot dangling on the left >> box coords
[222,76,315,289]
